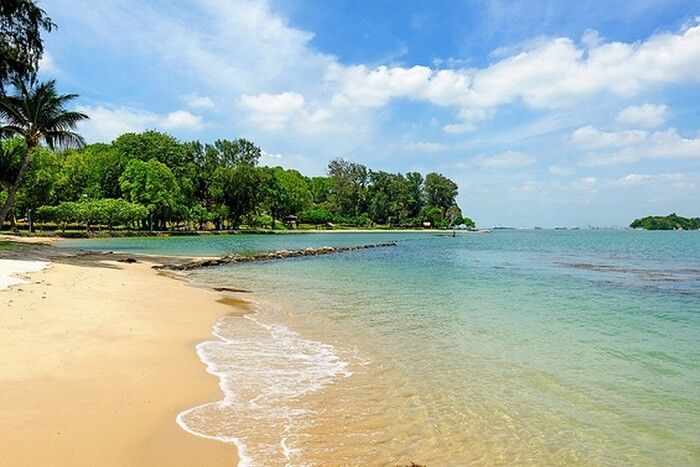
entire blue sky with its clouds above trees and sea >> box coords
[41,0,700,226]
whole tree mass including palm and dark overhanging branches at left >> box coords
[0,0,473,230]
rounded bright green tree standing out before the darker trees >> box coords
[119,159,180,230]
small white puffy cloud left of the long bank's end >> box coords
[239,92,304,130]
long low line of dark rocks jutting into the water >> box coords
[153,242,396,271]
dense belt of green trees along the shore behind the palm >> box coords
[0,131,473,230]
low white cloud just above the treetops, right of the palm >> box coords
[76,105,204,142]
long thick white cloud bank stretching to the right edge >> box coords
[326,20,700,126]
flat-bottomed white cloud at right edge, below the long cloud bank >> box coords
[583,128,700,166]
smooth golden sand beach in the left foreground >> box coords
[0,247,237,466]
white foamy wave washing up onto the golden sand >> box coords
[177,302,352,466]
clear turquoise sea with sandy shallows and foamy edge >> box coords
[67,231,700,465]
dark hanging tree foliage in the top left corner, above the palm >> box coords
[0,0,56,95]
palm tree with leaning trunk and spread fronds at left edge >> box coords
[0,80,88,229]
